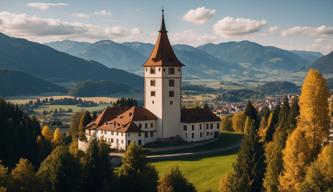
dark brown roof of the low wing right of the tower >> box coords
[181,108,221,123]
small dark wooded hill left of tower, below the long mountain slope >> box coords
[68,81,138,97]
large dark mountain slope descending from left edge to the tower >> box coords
[0,33,143,87]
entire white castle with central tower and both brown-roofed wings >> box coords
[79,10,220,150]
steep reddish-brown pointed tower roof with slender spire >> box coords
[144,10,184,67]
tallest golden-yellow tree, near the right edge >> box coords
[299,69,330,156]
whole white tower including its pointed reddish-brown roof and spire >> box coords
[144,10,184,138]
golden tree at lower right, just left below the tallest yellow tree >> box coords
[279,127,312,191]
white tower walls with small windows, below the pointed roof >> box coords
[144,67,182,138]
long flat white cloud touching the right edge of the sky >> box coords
[281,25,333,37]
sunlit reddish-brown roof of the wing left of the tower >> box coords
[88,106,157,133]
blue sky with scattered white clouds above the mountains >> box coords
[0,0,333,54]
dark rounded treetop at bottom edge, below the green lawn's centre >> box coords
[157,167,196,192]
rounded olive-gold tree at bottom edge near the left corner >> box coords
[10,158,37,191]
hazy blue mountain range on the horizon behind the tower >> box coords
[46,40,322,80]
